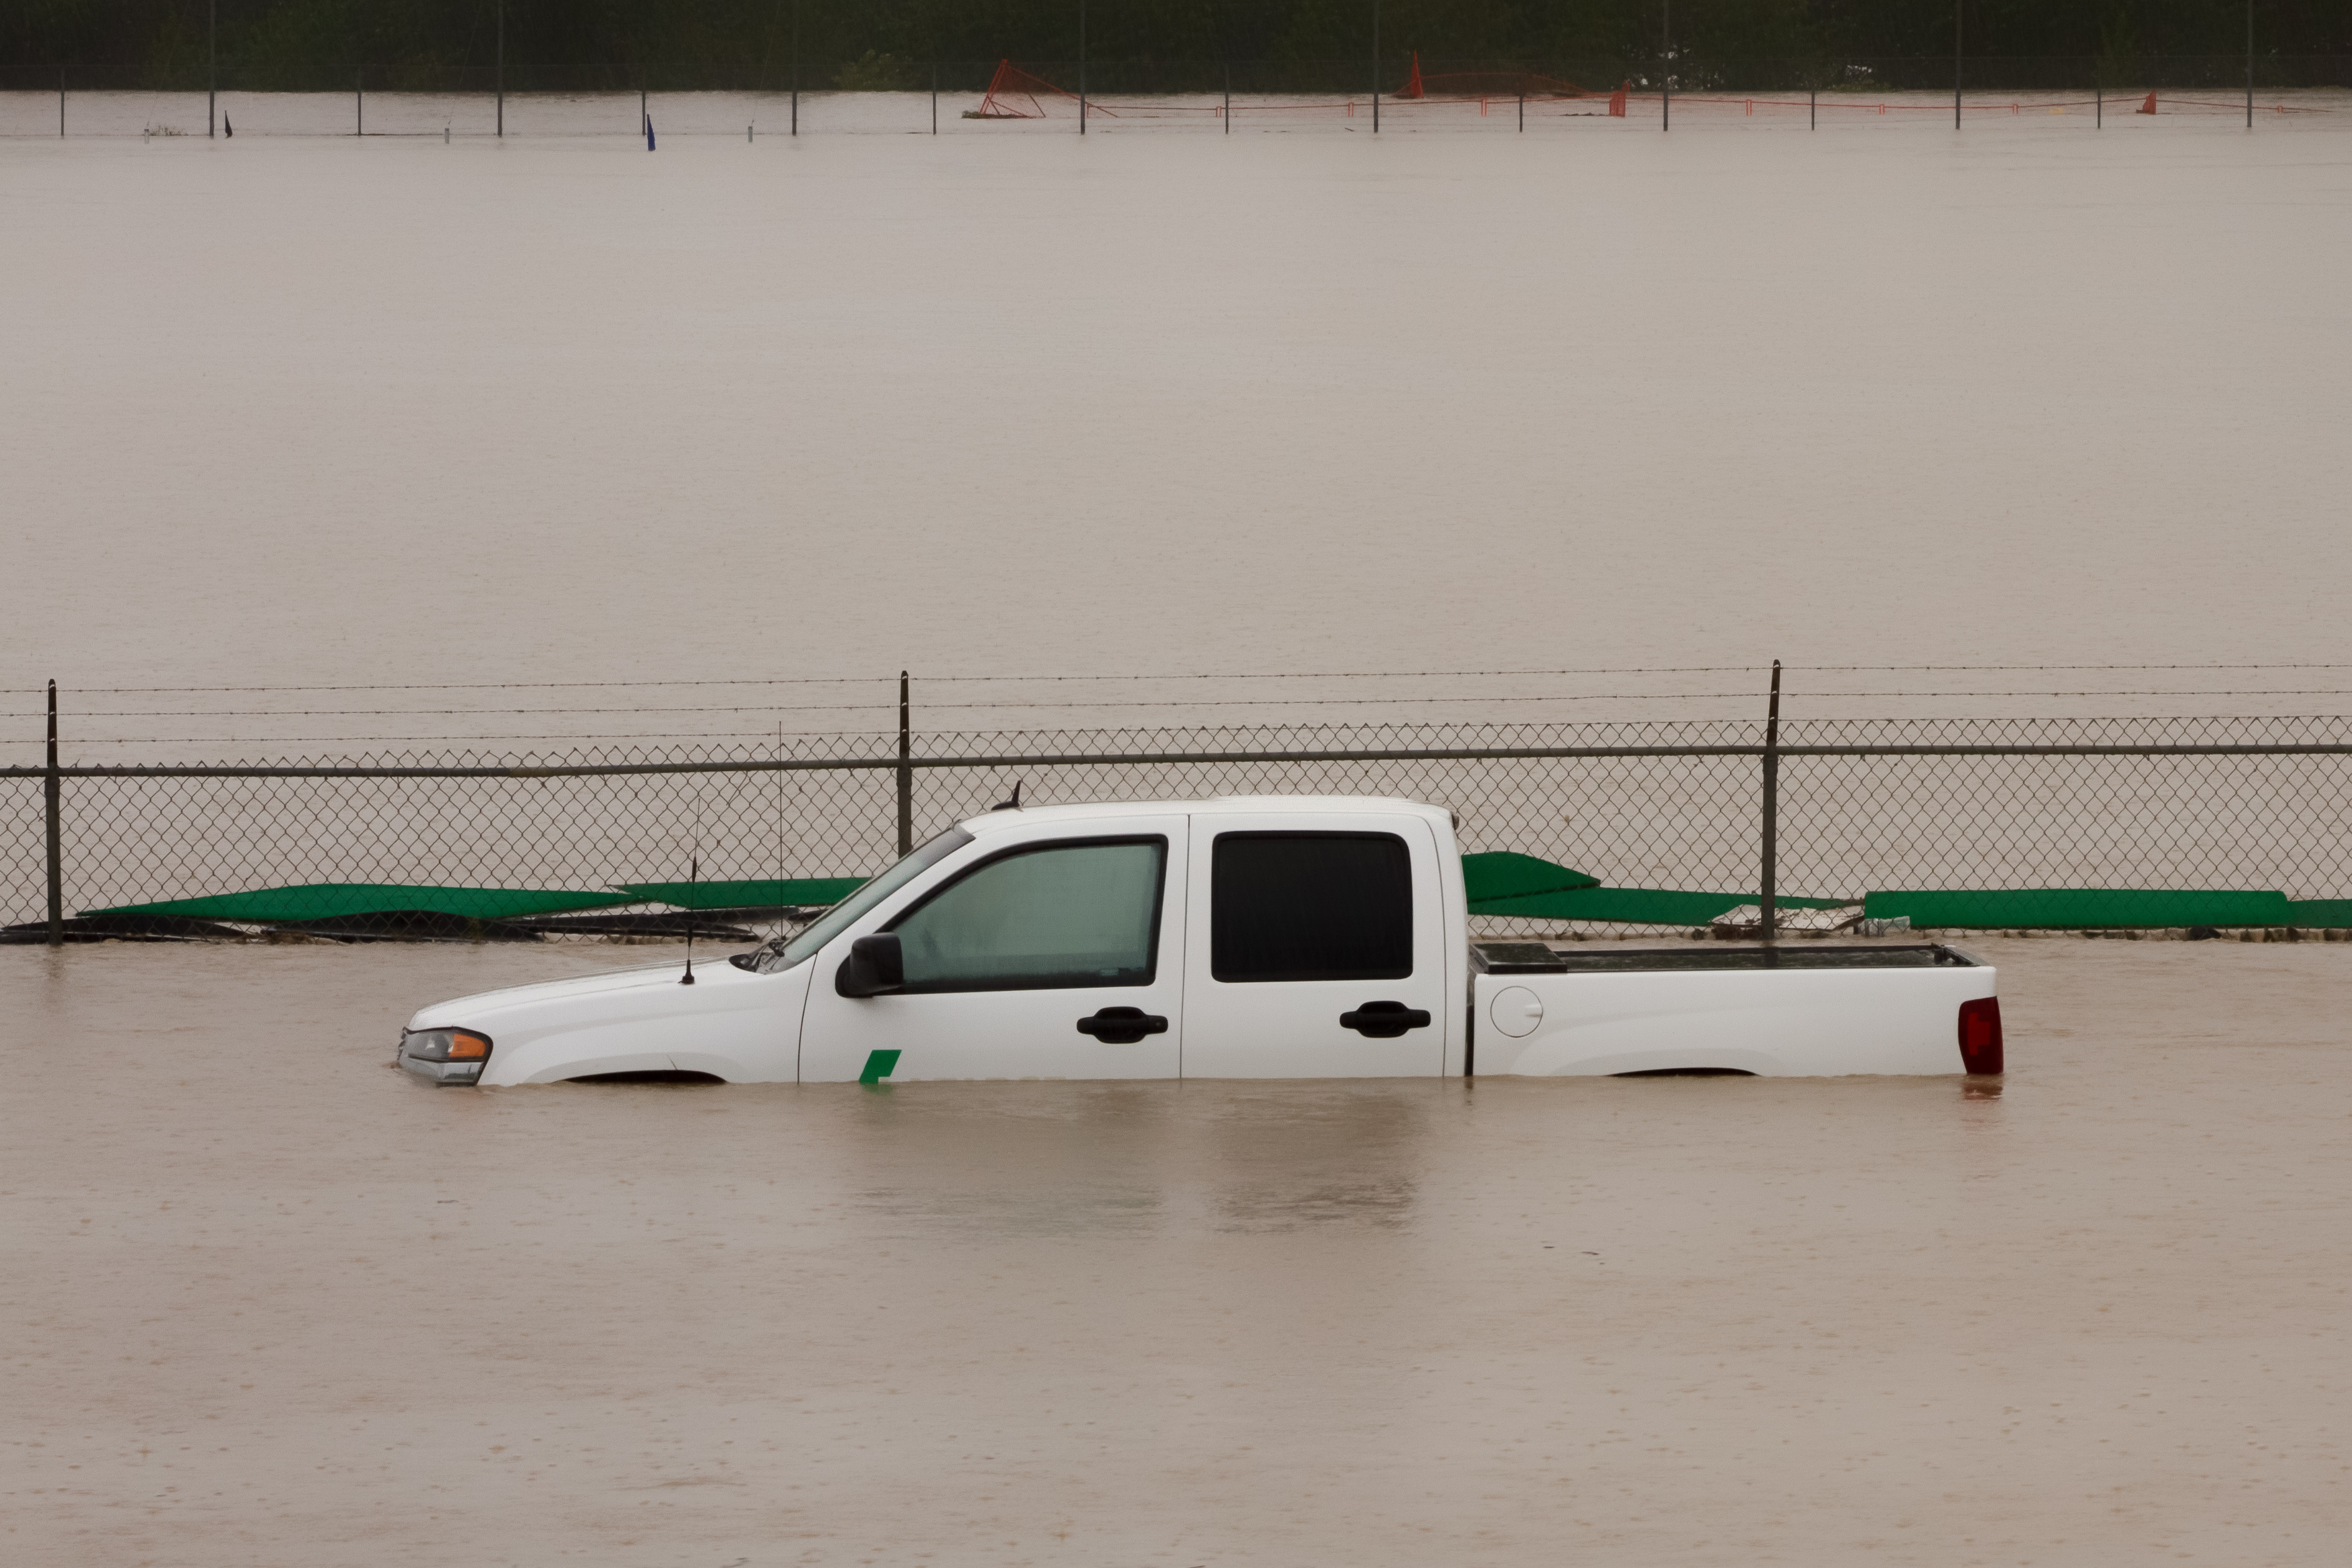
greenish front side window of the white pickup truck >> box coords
[892,839,1169,992]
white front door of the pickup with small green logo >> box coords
[800,816,1186,1084]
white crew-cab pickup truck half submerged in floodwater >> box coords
[397,795,2002,1084]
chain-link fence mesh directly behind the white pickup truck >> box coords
[0,717,2352,940]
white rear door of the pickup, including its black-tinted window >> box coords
[1183,811,1446,1079]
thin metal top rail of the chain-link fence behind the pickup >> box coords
[14,740,2352,778]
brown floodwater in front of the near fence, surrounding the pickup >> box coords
[0,940,2352,1568]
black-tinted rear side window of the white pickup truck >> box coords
[1209,832,1414,983]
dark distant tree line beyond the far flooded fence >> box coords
[0,0,2352,87]
